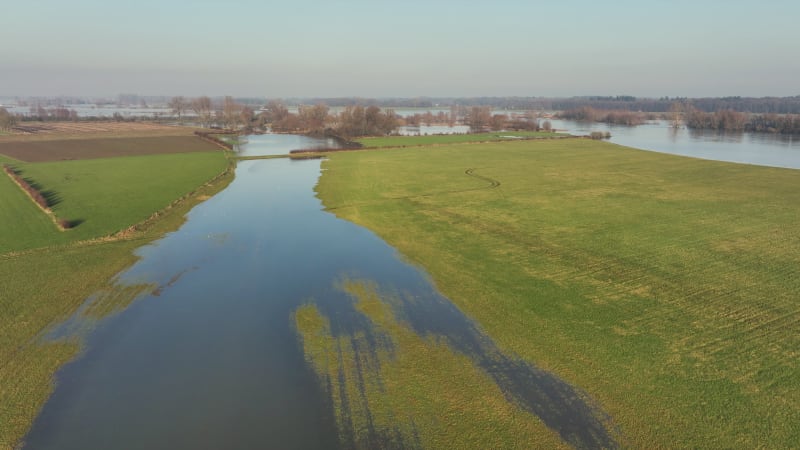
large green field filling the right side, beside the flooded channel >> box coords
[314,139,800,448]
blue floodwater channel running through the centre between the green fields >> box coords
[25,135,616,449]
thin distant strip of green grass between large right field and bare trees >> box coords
[356,131,567,147]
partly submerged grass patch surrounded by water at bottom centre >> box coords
[295,281,564,448]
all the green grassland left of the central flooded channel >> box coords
[0,132,232,448]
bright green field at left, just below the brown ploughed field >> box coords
[0,151,228,253]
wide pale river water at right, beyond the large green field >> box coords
[551,120,800,169]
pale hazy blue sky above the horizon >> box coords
[0,0,800,98]
